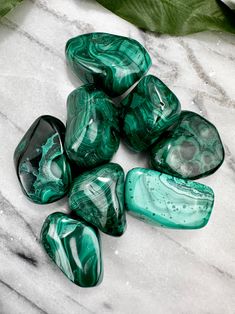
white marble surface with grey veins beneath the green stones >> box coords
[0,0,235,314]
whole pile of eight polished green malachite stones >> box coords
[14,33,224,287]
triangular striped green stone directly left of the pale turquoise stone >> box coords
[69,163,126,236]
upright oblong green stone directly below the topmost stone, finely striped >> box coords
[65,84,120,168]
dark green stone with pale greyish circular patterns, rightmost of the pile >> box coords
[151,111,224,179]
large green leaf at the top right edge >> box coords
[97,0,235,35]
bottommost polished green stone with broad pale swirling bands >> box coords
[41,212,103,287]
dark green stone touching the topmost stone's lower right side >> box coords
[122,75,181,152]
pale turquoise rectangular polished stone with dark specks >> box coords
[125,168,214,229]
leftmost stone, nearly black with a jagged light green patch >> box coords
[14,116,71,204]
